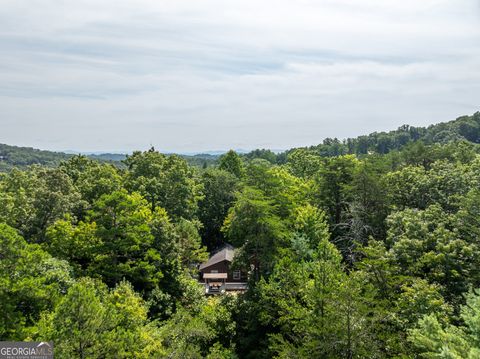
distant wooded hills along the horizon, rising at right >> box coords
[0,112,480,171]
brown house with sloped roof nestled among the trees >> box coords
[199,244,248,294]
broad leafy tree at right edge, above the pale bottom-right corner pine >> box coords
[387,205,480,304]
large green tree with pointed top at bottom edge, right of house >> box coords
[259,239,378,358]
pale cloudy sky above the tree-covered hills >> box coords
[0,0,480,152]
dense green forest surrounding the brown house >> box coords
[0,112,480,359]
